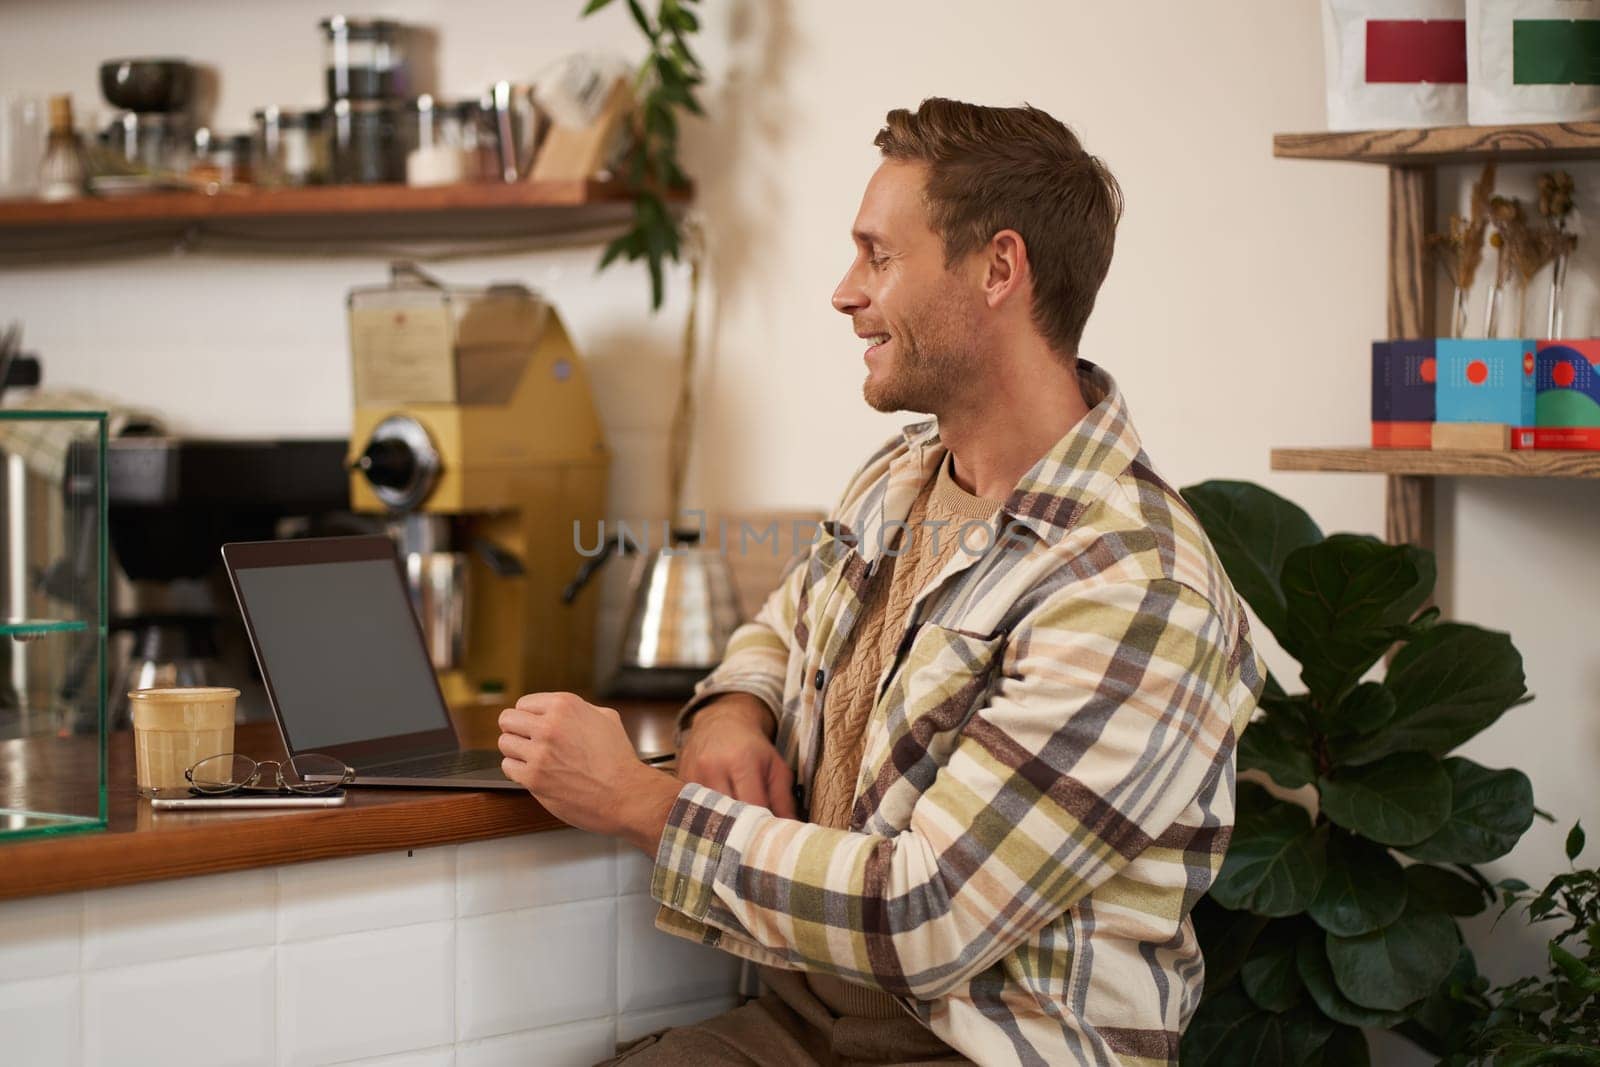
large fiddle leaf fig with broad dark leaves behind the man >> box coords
[1181,482,1534,1067]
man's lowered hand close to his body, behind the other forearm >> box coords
[678,693,795,819]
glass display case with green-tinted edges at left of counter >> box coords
[0,408,107,841]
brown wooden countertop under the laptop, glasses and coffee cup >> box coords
[0,701,680,899]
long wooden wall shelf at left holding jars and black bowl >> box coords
[0,181,675,230]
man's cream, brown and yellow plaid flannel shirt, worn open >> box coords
[651,363,1264,1064]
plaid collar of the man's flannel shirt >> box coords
[886,360,1142,542]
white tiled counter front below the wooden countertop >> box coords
[0,830,738,1067]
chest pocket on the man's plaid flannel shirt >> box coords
[856,622,1005,829]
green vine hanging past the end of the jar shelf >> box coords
[584,0,706,310]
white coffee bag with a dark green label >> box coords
[1467,0,1600,126]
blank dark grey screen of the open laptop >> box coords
[235,560,450,752]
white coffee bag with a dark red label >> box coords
[1322,0,1467,130]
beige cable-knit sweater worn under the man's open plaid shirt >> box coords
[806,458,1000,1019]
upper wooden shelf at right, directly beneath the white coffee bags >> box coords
[1272,122,1600,166]
